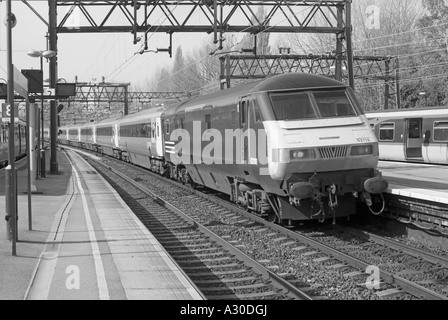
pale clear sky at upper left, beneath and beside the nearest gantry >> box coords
[0,0,214,87]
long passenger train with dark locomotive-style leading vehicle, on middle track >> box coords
[58,73,387,223]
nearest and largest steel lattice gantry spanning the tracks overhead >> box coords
[47,0,354,173]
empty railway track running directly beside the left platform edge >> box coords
[87,154,312,300]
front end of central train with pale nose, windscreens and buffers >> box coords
[260,74,387,220]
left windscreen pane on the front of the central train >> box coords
[271,93,317,120]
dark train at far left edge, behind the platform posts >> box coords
[0,120,26,168]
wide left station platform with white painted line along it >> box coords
[0,151,203,300]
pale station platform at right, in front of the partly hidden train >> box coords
[378,161,448,204]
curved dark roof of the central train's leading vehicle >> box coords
[165,73,347,115]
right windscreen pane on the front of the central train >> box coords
[314,91,356,118]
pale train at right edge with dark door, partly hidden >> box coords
[366,107,448,164]
